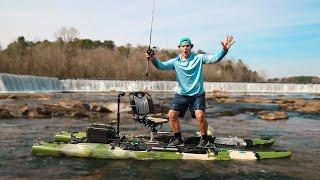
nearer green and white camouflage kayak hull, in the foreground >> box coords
[32,142,291,161]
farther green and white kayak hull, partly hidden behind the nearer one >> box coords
[54,131,275,147]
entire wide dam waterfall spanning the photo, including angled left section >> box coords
[0,74,320,94]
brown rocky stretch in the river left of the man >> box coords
[0,94,169,119]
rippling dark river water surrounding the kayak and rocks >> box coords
[0,94,320,179]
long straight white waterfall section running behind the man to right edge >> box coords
[61,79,320,94]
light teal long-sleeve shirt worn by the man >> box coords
[152,50,227,96]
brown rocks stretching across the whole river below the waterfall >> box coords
[0,91,320,120]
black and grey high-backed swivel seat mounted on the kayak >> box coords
[129,92,169,141]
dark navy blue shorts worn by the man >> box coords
[170,93,206,118]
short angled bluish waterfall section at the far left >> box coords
[0,73,63,92]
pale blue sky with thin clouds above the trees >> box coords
[0,0,320,78]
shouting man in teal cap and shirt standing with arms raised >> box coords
[146,36,234,148]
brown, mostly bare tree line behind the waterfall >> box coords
[0,28,264,82]
